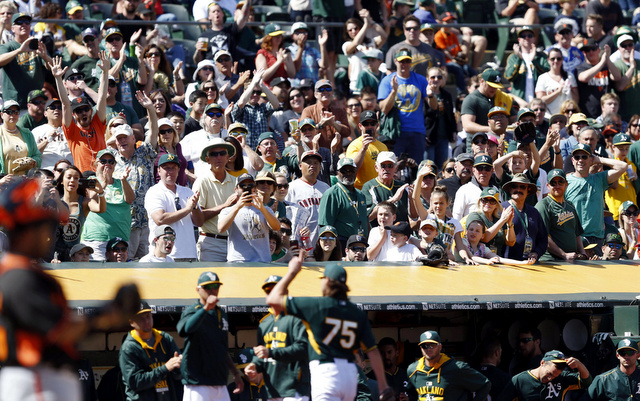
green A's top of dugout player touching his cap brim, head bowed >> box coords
[499,370,592,401]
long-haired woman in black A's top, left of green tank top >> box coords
[55,165,107,262]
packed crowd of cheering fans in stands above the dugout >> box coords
[0,0,640,264]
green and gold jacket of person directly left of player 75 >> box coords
[253,310,311,398]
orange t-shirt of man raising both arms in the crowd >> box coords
[62,114,107,171]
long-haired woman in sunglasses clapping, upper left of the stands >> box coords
[143,43,184,99]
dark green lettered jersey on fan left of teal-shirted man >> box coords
[536,195,582,261]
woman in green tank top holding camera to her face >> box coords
[81,145,135,260]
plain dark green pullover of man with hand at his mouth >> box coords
[177,301,229,386]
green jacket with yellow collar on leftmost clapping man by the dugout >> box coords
[118,329,182,401]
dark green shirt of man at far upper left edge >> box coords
[0,40,45,109]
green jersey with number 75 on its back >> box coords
[283,297,376,363]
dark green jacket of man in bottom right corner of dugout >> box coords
[589,366,640,401]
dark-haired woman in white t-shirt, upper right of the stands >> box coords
[535,48,579,118]
